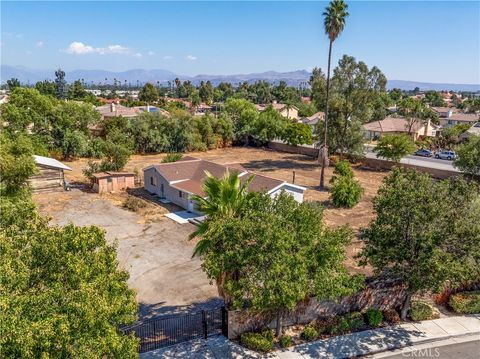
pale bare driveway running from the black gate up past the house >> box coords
[35,190,221,318]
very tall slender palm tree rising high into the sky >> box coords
[318,0,348,189]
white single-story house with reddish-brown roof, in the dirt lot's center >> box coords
[143,156,306,213]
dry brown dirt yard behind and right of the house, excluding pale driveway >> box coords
[62,147,387,272]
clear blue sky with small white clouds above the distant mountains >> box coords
[0,1,480,83]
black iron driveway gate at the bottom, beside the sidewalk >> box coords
[122,307,227,353]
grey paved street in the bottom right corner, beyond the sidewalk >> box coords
[378,341,480,359]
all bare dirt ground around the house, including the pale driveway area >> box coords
[34,147,386,317]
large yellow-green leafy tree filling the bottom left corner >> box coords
[0,202,138,358]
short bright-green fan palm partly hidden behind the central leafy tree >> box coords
[190,172,254,304]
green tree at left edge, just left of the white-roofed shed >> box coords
[0,131,37,195]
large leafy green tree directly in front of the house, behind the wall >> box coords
[191,187,360,336]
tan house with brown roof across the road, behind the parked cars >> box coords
[363,116,440,140]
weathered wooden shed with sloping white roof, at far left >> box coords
[29,155,72,192]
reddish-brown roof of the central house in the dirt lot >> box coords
[144,156,305,196]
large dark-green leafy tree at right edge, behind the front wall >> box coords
[360,168,480,319]
